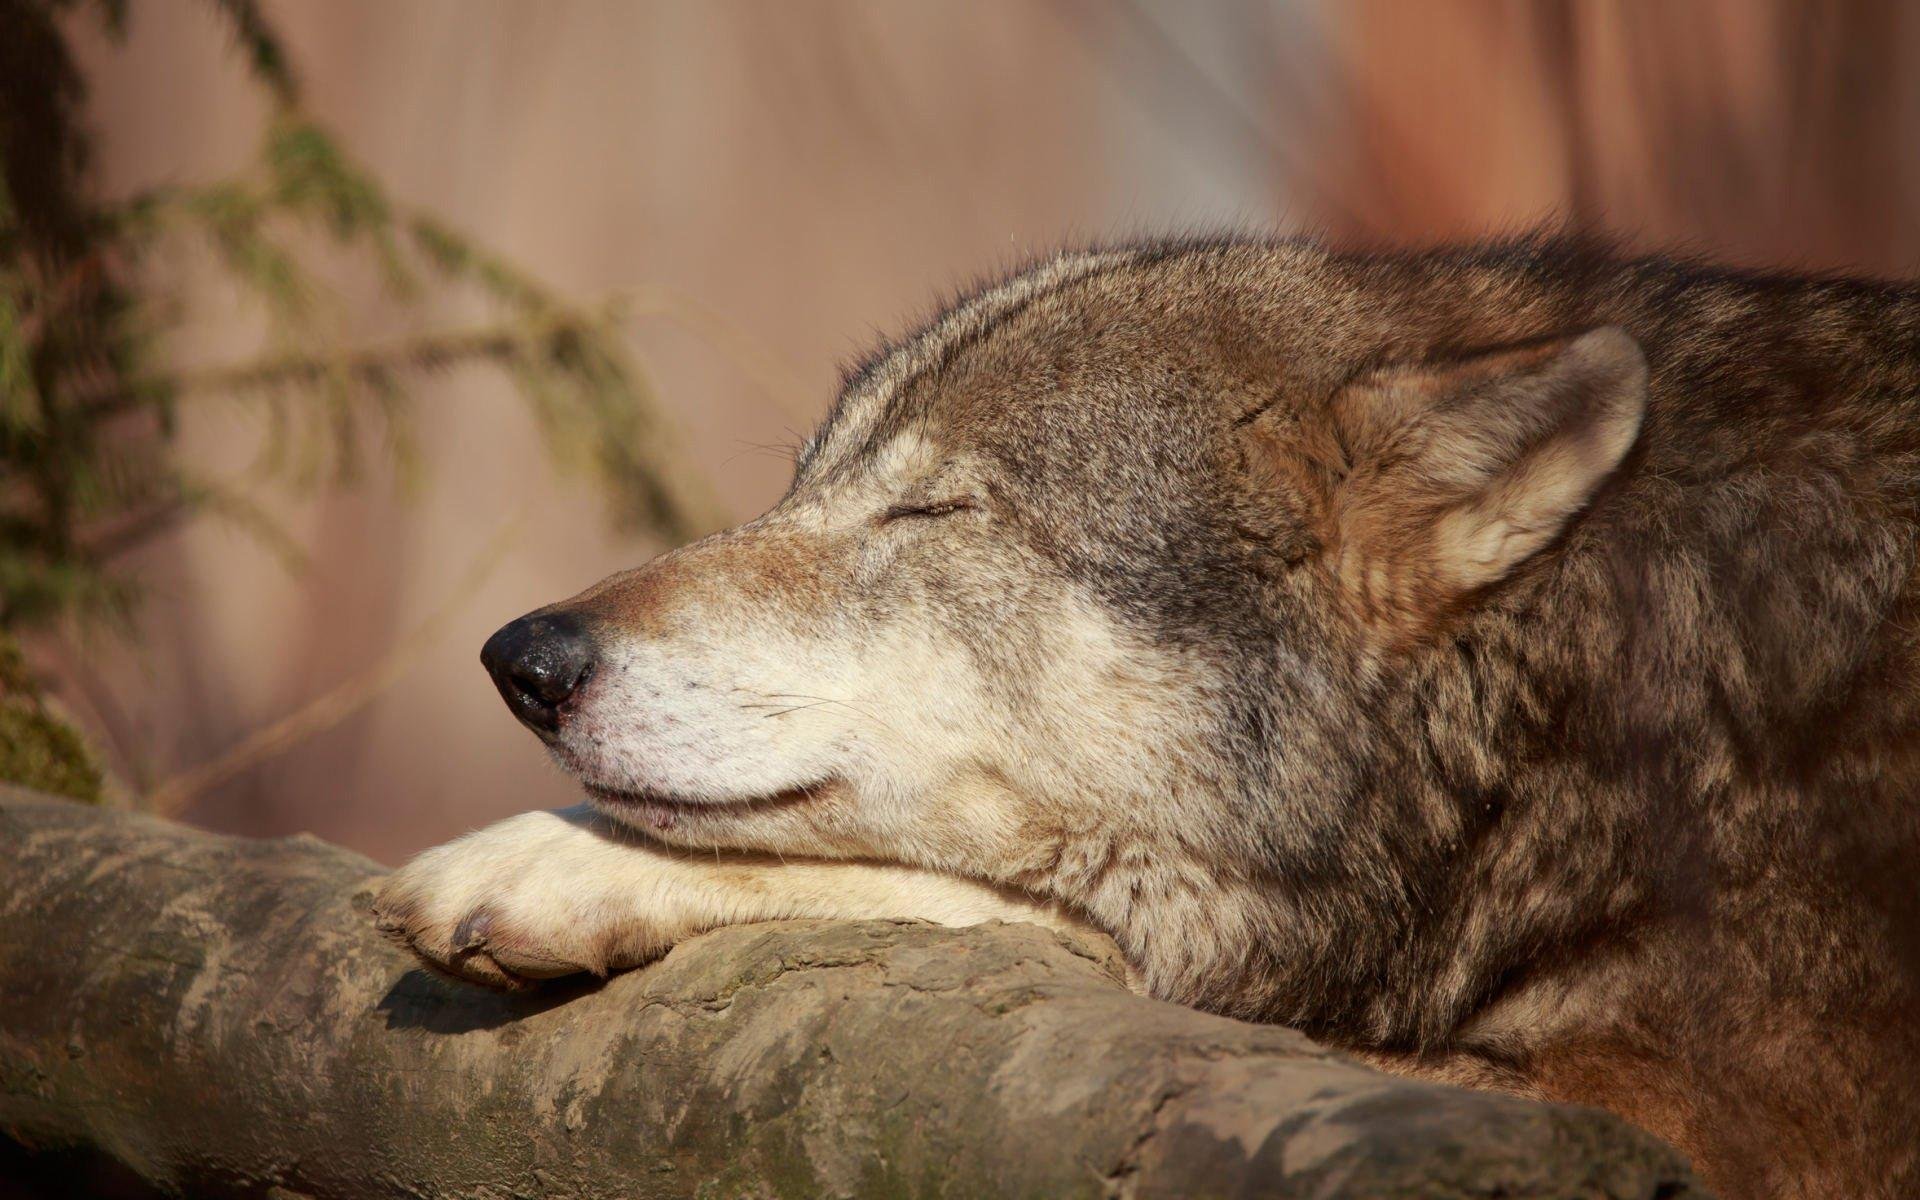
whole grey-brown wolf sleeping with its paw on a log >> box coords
[376,236,1920,1196]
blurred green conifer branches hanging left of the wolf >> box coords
[0,0,722,806]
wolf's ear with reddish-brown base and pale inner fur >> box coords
[1327,326,1647,634]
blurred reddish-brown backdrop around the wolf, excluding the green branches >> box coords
[36,0,1920,860]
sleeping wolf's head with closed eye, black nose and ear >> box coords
[484,244,1647,1021]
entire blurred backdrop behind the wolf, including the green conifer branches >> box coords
[0,0,1920,862]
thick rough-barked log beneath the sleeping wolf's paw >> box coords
[0,793,1699,1198]
